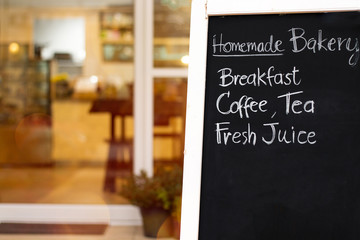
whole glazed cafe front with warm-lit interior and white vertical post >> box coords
[0,0,190,233]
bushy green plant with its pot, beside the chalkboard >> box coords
[121,167,182,237]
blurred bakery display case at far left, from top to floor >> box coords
[0,44,52,166]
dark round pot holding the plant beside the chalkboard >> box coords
[140,207,173,238]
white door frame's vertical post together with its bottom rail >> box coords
[0,0,148,225]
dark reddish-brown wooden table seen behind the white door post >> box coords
[90,98,185,192]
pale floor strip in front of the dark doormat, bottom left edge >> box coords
[0,226,175,240]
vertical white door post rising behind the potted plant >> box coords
[134,0,153,175]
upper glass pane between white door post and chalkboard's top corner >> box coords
[154,0,190,67]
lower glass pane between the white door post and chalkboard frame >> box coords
[154,78,187,170]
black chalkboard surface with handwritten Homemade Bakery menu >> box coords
[199,12,360,240]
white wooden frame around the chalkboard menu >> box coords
[180,0,360,240]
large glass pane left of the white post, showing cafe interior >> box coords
[0,0,134,204]
